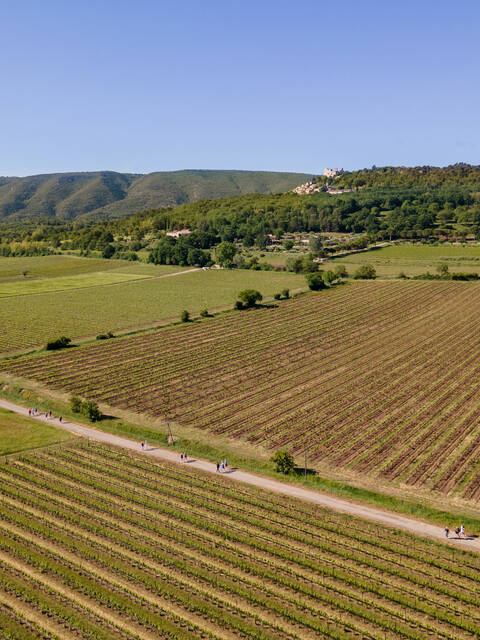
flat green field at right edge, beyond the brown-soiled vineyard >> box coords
[322,244,480,278]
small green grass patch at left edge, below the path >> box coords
[0,408,72,455]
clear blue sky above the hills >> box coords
[0,0,480,175]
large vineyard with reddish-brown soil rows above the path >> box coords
[8,281,480,502]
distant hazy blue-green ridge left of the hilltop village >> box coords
[0,170,312,221]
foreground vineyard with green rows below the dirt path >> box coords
[0,443,480,640]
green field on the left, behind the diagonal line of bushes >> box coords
[0,259,306,353]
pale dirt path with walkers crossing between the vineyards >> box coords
[0,399,480,553]
